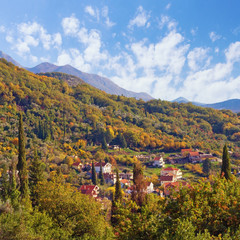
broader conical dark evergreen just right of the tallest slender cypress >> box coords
[29,149,43,206]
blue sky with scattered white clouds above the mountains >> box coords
[0,0,240,103]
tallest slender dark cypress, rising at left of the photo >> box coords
[17,114,30,206]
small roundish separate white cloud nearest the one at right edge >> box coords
[187,47,211,71]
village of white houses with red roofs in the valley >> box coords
[72,149,222,201]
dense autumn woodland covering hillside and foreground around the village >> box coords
[0,59,240,239]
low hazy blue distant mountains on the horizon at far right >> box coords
[172,97,240,113]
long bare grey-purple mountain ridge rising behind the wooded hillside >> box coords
[26,62,153,101]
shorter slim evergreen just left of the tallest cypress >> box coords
[9,161,20,210]
